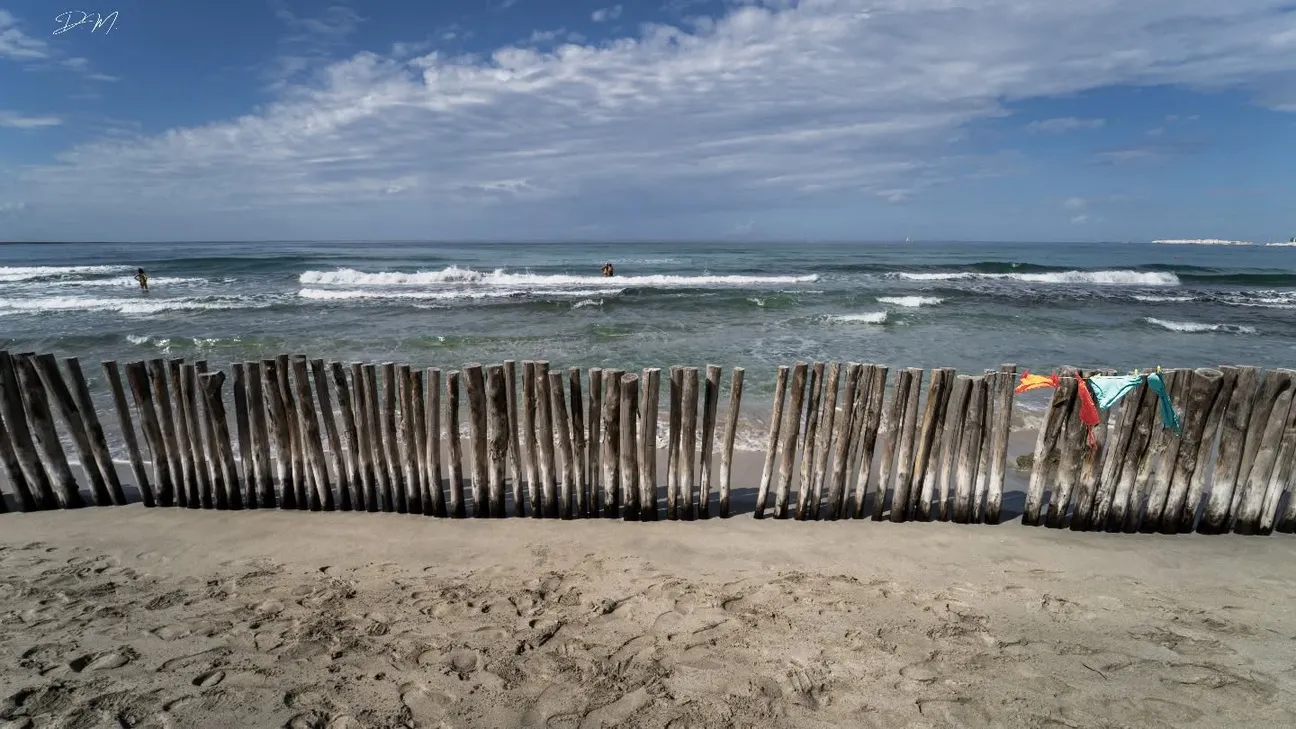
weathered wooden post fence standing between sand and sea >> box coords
[0,352,1296,534]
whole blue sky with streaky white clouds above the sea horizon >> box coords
[0,0,1296,241]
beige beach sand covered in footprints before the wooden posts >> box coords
[0,446,1296,729]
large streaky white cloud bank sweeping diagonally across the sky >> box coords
[0,0,1296,237]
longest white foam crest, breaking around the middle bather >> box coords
[298,266,819,288]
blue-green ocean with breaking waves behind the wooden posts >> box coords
[0,241,1296,445]
